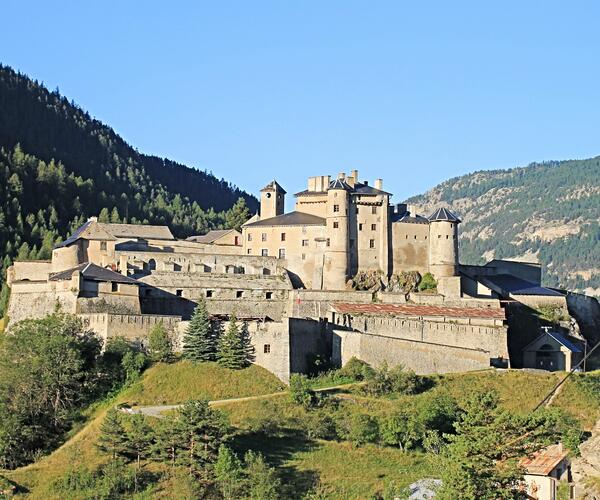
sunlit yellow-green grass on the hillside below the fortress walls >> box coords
[6,362,600,498]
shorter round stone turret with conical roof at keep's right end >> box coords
[429,208,460,279]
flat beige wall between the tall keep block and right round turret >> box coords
[392,222,429,274]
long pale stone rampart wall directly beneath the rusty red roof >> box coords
[333,316,509,374]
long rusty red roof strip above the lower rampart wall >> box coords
[332,302,506,320]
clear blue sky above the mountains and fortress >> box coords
[0,0,600,205]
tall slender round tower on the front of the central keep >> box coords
[323,178,350,290]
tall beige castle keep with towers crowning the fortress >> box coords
[242,170,460,290]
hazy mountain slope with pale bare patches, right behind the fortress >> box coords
[407,156,600,295]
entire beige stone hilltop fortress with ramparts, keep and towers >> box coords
[8,170,600,381]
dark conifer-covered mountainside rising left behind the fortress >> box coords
[0,65,258,313]
